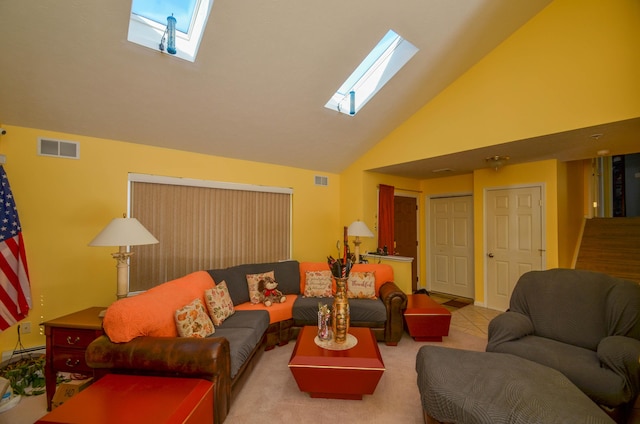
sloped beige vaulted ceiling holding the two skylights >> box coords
[0,0,638,178]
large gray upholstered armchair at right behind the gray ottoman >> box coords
[487,269,640,422]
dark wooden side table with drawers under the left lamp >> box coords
[42,306,105,411]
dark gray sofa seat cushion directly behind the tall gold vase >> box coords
[293,296,387,326]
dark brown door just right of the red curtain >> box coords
[393,196,418,292]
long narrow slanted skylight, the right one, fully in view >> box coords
[324,30,418,116]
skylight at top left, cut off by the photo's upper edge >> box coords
[127,0,213,62]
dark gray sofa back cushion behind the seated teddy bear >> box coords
[207,260,300,305]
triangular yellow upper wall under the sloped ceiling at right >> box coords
[354,0,640,169]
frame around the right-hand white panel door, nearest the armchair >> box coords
[482,182,548,307]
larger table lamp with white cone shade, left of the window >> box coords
[89,217,159,299]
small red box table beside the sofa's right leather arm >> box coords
[404,294,451,342]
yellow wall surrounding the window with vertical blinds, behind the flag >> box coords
[0,125,342,351]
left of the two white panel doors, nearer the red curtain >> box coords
[429,196,475,299]
